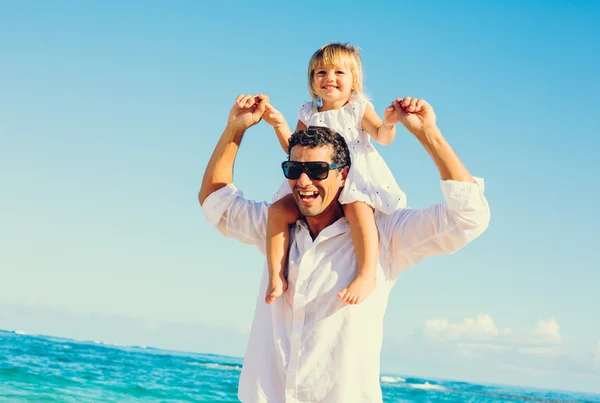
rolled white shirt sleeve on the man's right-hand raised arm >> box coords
[382,178,490,280]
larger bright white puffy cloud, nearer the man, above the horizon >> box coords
[423,314,500,340]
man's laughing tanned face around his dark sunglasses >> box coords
[288,146,348,217]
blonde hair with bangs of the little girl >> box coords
[308,43,363,101]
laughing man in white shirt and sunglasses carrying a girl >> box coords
[198,95,489,403]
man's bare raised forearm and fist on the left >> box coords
[198,95,268,205]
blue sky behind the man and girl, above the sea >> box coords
[0,1,600,398]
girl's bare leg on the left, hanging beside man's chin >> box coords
[265,195,300,304]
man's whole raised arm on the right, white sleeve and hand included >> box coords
[382,97,490,277]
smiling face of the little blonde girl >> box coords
[312,64,352,103]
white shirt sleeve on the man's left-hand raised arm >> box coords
[202,184,269,253]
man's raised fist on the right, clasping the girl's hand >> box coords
[383,97,437,137]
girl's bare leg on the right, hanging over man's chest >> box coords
[338,202,379,304]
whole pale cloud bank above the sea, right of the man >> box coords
[382,313,600,392]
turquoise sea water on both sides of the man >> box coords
[0,331,600,403]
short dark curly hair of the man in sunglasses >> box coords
[288,126,350,166]
